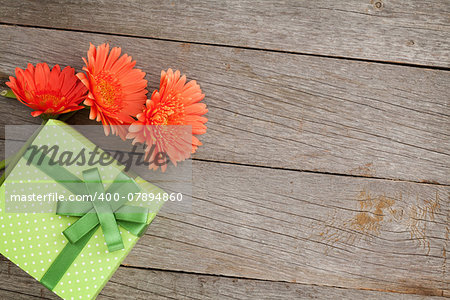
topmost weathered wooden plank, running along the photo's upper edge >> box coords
[0,0,450,67]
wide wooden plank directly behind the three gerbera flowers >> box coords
[0,26,450,184]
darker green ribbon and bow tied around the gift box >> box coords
[24,149,149,290]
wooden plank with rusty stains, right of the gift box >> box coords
[120,161,450,296]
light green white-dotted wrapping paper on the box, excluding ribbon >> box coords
[0,120,164,299]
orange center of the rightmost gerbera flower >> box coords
[150,94,186,125]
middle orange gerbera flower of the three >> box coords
[77,44,148,139]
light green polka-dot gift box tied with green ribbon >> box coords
[0,120,164,299]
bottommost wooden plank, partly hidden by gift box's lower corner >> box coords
[0,255,442,300]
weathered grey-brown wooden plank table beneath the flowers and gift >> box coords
[0,0,450,299]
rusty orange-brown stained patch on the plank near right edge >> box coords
[318,189,450,262]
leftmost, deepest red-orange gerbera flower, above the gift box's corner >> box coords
[6,63,87,117]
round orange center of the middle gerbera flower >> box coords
[94,72,123,113]
